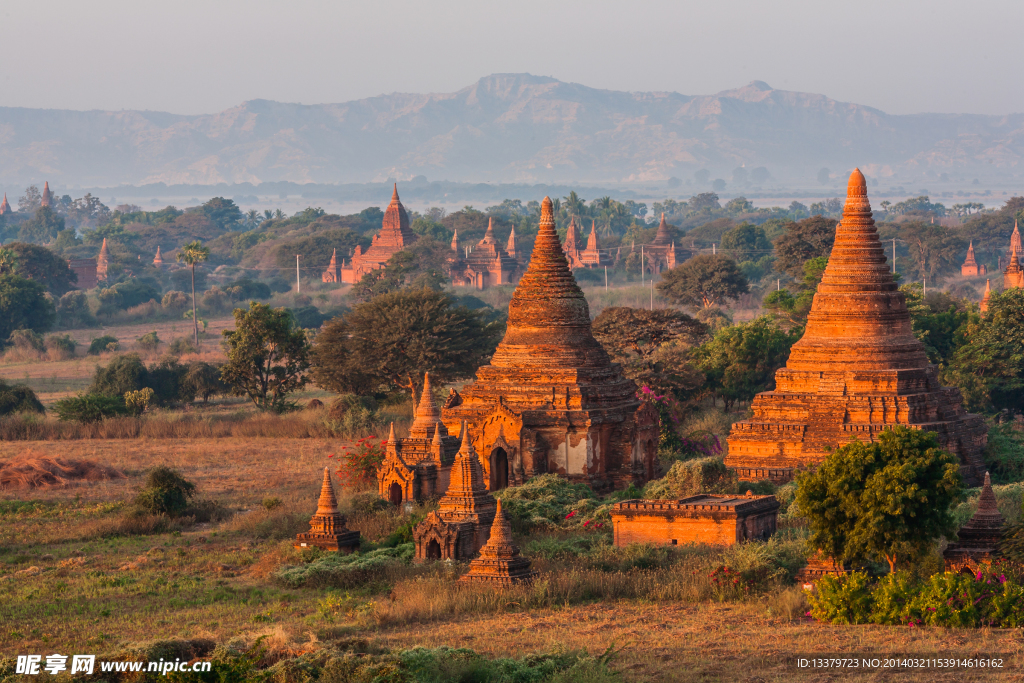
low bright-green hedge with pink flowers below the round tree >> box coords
[808,564,1024,628]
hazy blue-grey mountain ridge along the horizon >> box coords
[0,74,1024,186]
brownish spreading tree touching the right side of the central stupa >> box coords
[594,306,708,393]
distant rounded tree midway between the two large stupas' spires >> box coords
[657,254,750,308]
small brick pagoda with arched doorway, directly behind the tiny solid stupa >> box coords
[413,424,498,562]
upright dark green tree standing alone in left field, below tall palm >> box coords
[220,301,310,412]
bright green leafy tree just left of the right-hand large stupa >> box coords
[692,315,799,408]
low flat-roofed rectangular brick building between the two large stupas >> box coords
[611,493,779,547]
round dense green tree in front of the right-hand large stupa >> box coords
[796,427,961,571]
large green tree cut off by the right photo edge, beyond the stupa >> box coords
[943,288,1024,411]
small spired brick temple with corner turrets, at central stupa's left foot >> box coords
[377,373,459,505]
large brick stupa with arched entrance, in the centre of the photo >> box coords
[441,198,659,490]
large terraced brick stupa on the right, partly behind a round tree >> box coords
[725,170,987,485]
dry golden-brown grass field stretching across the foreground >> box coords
[0,438,1024,682]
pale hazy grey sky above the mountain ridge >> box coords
[0,0,1024,114]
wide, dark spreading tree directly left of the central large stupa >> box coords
[312,289,503,394]
